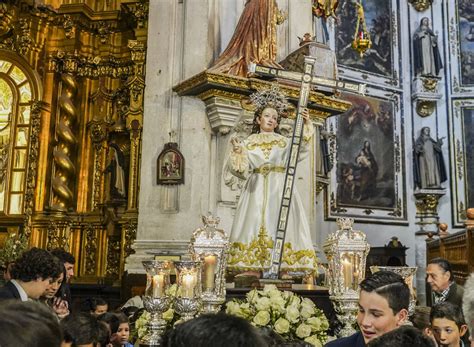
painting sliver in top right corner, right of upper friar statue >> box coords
[457,0,474,86]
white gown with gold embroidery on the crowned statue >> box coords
[227,126,316,271]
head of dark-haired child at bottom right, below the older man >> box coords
[430,302,467,347]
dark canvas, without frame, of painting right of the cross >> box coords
[336,96,396,209]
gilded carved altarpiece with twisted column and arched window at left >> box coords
[0,0,148,284]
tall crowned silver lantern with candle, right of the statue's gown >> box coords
[323,218,370,336]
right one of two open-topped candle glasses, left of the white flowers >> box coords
[174,260,202,321]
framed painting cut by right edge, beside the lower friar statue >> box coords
[450,99,474,227]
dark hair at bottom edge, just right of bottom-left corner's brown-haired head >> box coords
[61,312,99,346]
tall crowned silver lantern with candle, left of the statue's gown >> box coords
[189,215,229,313]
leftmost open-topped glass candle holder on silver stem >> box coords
[140,260,173,346]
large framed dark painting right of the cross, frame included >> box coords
[325,91,407,224]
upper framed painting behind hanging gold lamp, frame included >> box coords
[331,0,406,87]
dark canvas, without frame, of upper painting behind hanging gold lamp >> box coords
[336,0,394,77]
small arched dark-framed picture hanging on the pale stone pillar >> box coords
[156,142,184,185]
